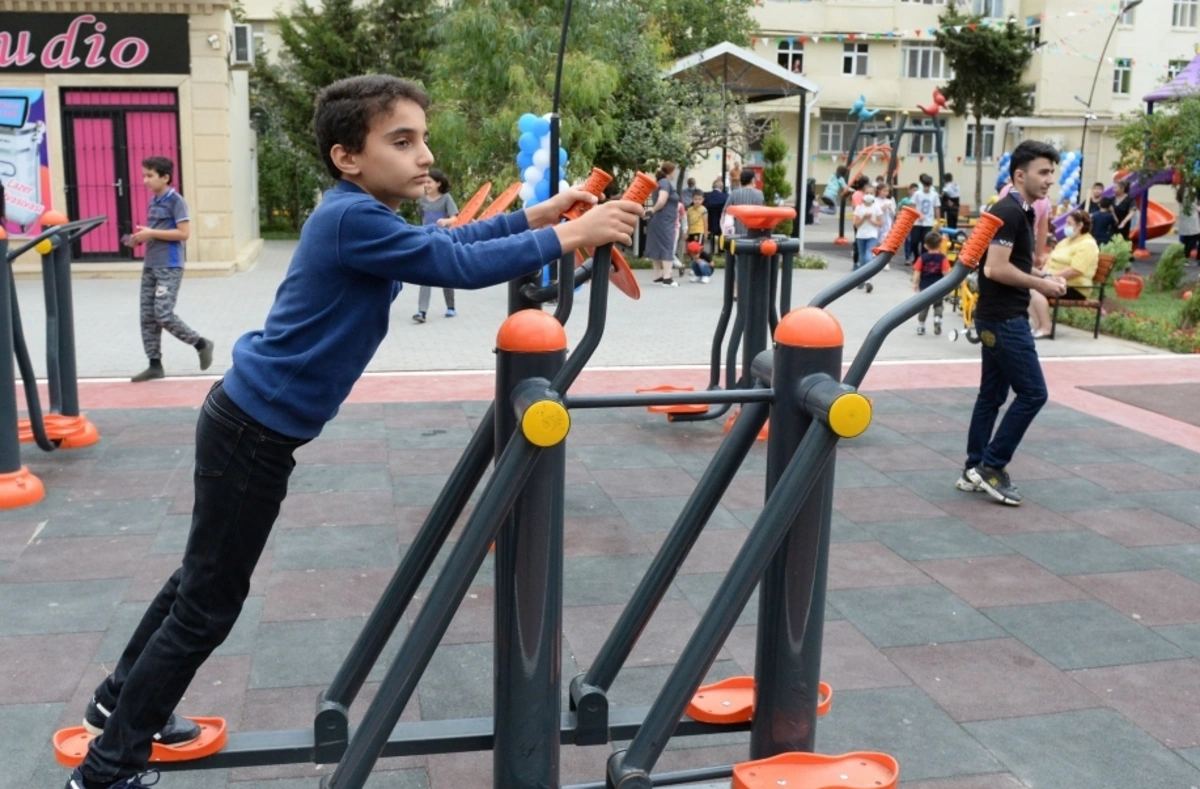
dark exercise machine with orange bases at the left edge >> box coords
[0,211,106,508]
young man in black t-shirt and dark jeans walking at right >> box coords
[955,140,1067,506]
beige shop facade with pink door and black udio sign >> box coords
[0,0,262,275]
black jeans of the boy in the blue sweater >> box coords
[82,383,307,784]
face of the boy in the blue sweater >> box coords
[330,98,437,210]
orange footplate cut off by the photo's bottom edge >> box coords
[732,751,900,789]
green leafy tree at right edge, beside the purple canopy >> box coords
[1116,96,1200,213]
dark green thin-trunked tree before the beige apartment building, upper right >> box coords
[934,4,1033,205]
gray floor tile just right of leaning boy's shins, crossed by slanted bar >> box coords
[248,619,408,689]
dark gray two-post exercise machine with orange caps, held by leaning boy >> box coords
[42,182,996,789]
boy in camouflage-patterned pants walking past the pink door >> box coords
[126,156,212,384]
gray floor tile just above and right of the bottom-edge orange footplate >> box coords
[817,687,1003,789]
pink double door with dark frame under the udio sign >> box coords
[62,89,182,260]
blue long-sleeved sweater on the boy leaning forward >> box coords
[224,181,563,439]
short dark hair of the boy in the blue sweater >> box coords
[312,74,430,181]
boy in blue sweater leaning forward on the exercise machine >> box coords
[66,76,642,789]
